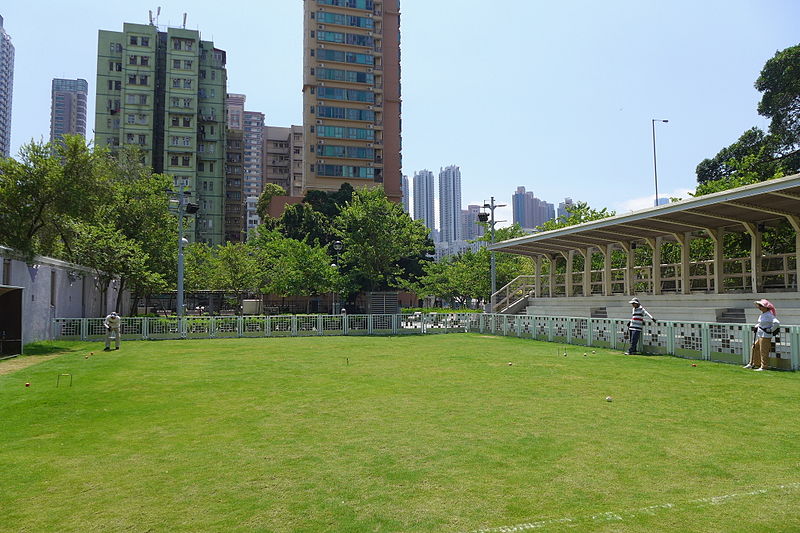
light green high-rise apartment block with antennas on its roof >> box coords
[95,23,227,244]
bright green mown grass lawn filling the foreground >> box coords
[0,334,800,532]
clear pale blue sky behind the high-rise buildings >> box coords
[0,0,800,226]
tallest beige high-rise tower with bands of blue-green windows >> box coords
[303,0,402,202]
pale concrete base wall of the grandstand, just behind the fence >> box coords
[526,292,800,325]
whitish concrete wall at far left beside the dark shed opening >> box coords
[0,247,130,343]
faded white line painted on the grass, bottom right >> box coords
[470,482,800,533]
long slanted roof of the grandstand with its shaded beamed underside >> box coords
[489,174,800,255]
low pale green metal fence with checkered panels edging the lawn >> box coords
[53,313,800,370]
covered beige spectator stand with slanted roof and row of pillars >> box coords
[489,174,800,324]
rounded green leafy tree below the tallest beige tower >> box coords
[334,188,433,291]
